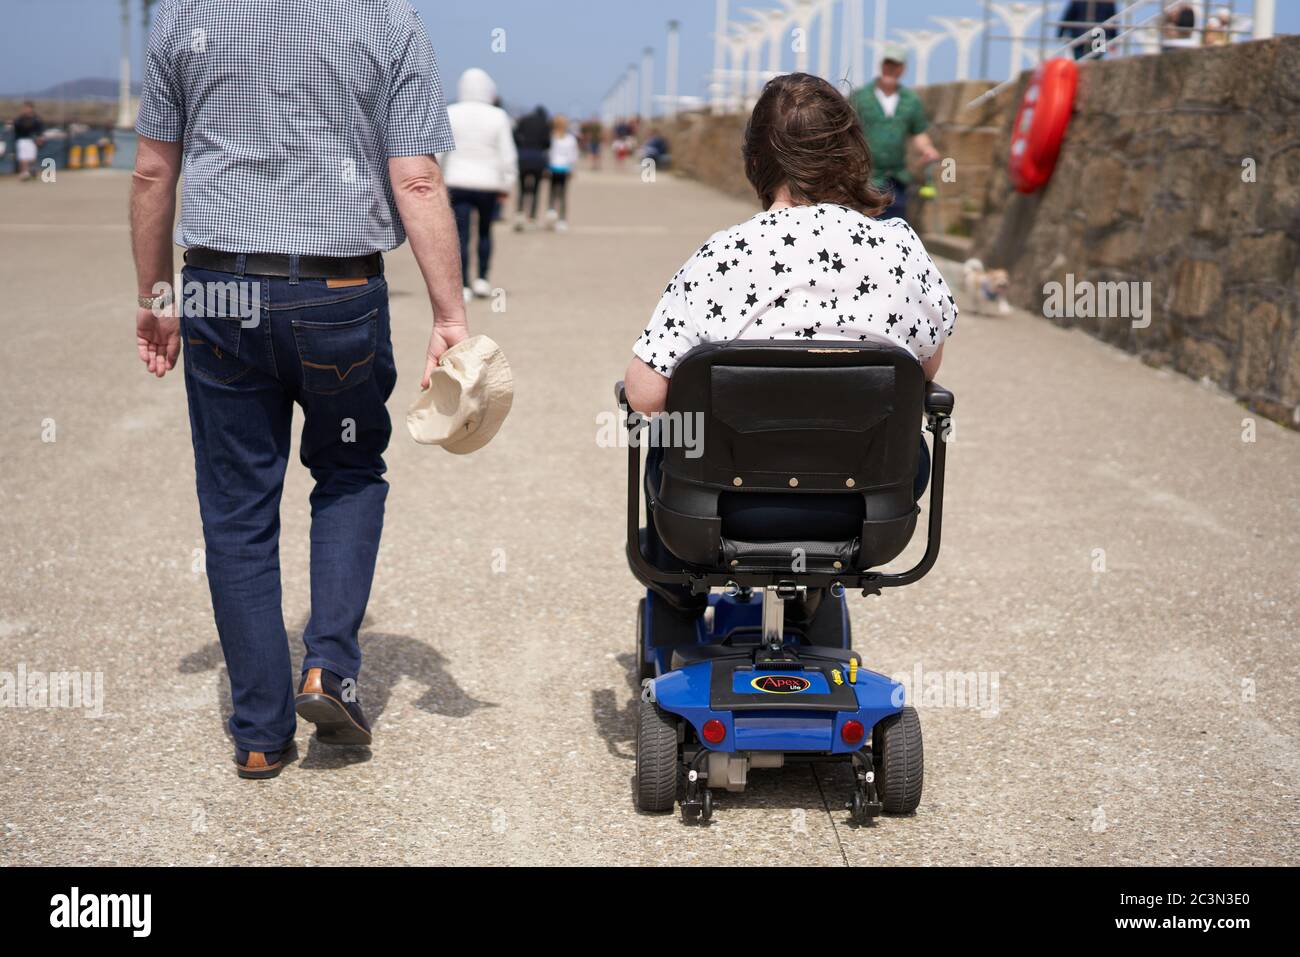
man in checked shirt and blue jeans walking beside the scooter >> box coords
[131,0,467,778]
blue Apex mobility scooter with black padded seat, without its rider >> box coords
[616,338,953,824]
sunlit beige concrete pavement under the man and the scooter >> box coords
[0,172,1300,865]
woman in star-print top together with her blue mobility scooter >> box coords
[619,74,957,820]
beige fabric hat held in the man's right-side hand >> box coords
[407,335,515,455]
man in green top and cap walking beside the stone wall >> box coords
[849,43,939,220]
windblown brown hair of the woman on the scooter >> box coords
[744,73,888,216]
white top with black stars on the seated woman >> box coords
[632,204,957,376]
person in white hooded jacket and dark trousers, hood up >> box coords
[441,68,517,302]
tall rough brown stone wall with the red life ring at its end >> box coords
[975,36,1300,425]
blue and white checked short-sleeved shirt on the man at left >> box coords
[135,0,455,256]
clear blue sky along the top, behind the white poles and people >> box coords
[0,0,1300,116]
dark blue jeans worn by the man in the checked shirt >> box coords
[181,268,397,752]
